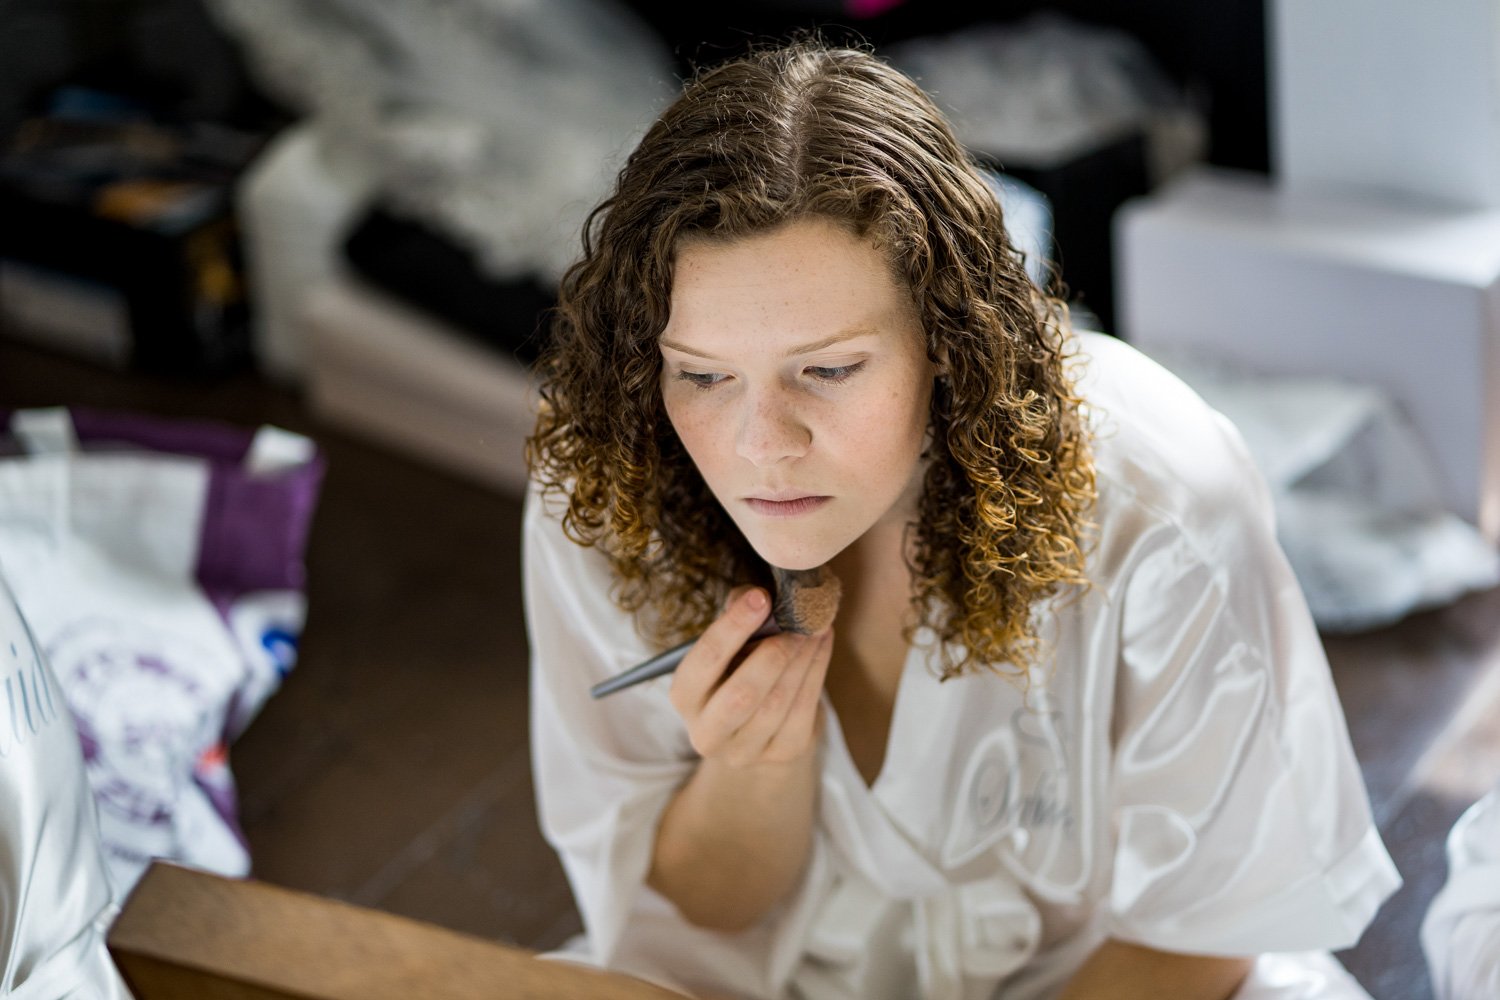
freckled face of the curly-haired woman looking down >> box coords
[660,212,936,570]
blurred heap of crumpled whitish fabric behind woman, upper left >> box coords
[207,0,677,282]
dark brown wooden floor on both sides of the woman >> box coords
[0,340,1500,1000]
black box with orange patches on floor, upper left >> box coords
[0,110,258,375]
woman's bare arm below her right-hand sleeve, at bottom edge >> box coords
[1058,940,1256,1000]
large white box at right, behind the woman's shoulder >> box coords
[1115,171,1500,541]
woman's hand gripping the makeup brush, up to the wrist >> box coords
[671,588,833,768]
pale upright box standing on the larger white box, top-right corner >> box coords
[1268,0,1500,208]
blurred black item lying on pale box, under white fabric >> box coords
[344,204,557,366]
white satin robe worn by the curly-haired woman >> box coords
[524,334,1400,1000]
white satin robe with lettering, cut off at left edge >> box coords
[0,569,131,1000]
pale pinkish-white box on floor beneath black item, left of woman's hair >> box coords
[300,276,537,495]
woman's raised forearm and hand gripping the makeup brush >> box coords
[647,589,833,931]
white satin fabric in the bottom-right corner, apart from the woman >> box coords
[1422,787,1500,1000]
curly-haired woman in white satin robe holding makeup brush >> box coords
[525,43,1397,1000]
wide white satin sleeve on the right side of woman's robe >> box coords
[1109,438,1400,955]
